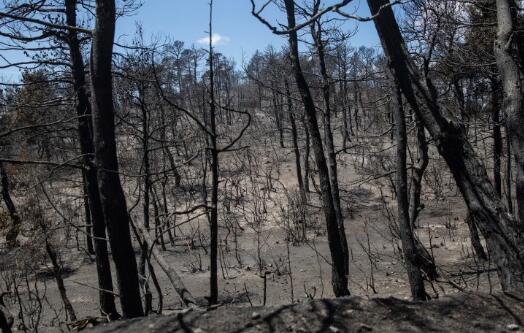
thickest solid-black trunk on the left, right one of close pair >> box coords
[91,0,144,318]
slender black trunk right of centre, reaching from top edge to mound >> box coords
[285,0,349,297]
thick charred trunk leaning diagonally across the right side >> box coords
[367,0,524,290]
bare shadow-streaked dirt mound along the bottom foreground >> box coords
[91,292,524,333]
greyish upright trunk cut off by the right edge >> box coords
[494,0,524,224]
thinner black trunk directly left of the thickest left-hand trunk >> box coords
[65,0,119,319]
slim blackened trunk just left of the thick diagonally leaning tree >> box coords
[393,84,429,300]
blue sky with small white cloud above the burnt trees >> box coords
[117,0,379,65]
